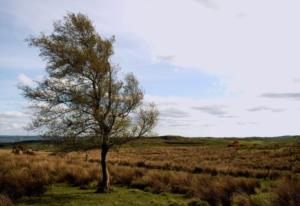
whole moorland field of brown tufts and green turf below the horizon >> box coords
[0,137,300,206]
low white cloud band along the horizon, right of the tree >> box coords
[146,96,300,137]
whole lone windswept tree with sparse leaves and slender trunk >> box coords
[21,13,158,192]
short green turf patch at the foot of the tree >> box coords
[17,185,186,206]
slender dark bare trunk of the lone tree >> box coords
[97,145,110,193]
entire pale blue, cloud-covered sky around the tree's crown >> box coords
[0,0,300,137]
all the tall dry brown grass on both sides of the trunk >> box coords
[0,139,300,206]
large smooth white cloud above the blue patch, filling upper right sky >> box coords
[123,0,300,95]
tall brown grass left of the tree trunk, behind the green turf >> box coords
[0,150,100,199]
